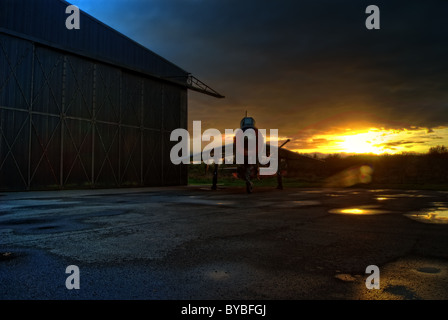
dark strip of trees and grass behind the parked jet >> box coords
[188,161,448,191]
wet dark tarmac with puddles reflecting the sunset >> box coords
[0,186,448,300]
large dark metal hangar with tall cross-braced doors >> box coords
[0,0,188,190]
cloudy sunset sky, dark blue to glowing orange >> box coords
[69,0,448,154]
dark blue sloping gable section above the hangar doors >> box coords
[0,0,223,98]
